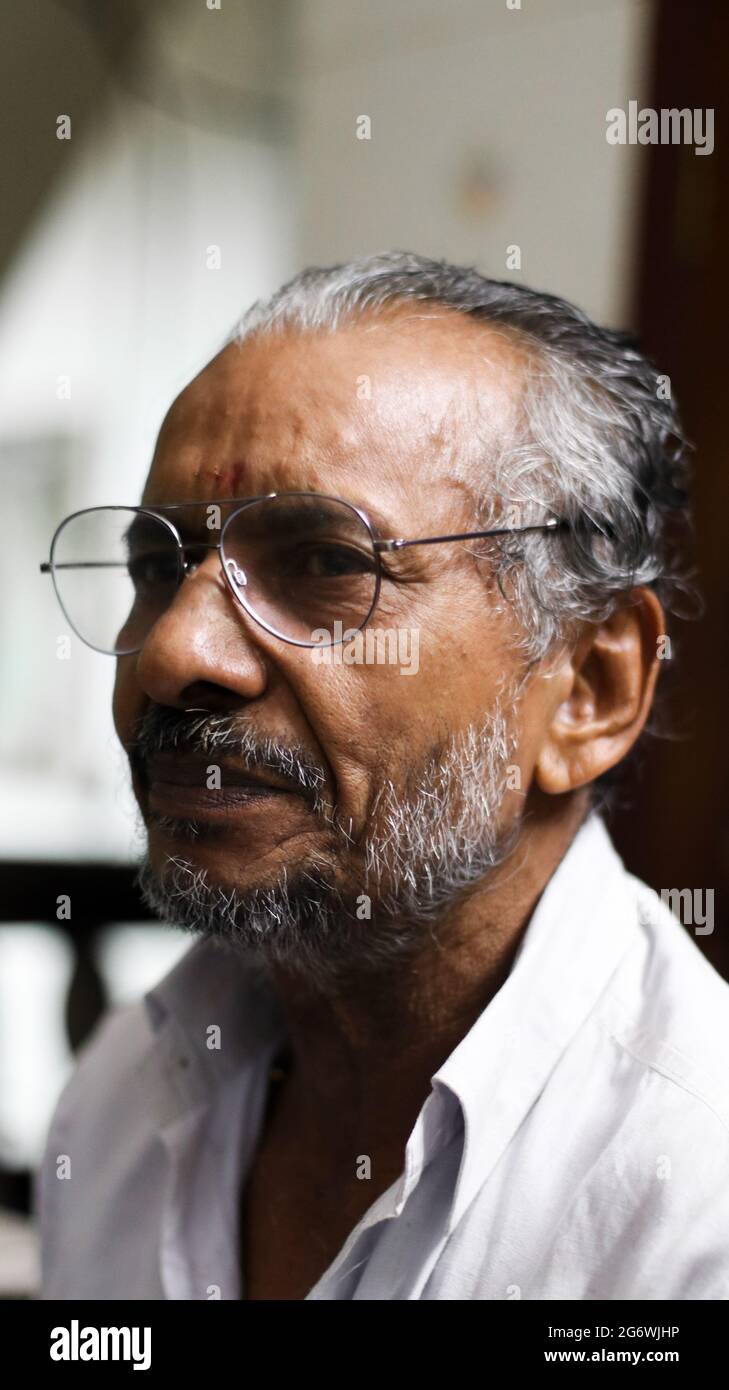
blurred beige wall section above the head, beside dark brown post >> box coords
[296,0,652,324]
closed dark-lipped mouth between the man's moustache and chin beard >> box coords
[141,752,301,820]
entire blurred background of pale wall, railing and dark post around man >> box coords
[0,0,729,1297]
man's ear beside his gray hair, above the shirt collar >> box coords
[534,588,665,795]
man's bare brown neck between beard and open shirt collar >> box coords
[267,806,584,1152]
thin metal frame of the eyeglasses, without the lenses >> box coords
[40,492,568,656]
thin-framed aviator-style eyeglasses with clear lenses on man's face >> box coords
[40,492,565,656]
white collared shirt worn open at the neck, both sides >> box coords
[36,813,729,1300]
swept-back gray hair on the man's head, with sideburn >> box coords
[234,252,690,662]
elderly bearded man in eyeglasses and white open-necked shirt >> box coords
[39,253,729,1300]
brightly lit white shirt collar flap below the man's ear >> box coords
[433,812,637,1230]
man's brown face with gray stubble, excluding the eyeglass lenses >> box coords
[114,311,553,973]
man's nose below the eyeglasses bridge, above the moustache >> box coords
[136,552,267,709]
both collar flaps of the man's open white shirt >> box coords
[145,813,636,1229]
